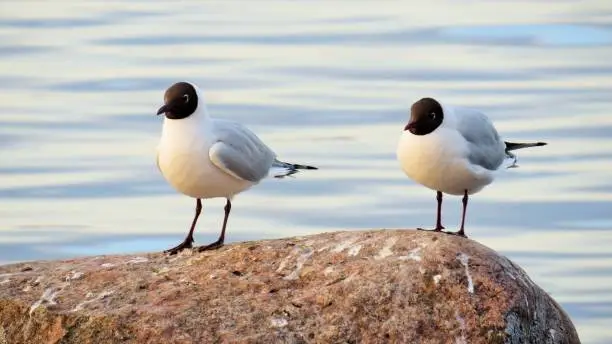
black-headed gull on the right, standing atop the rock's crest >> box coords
[396,98,546,237]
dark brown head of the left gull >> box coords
[157,81,200,119]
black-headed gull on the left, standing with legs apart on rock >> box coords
[157,82,317,255]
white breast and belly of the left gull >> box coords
[157,114,252,198]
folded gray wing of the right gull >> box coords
[455,108,505,170]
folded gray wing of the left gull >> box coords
[208,119,276,182]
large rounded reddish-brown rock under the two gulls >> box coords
[0,230,580,344]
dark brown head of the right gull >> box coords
[404,98,444,136]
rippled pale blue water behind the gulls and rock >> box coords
[0,1,612,343]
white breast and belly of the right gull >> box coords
[397,126,493,195]
